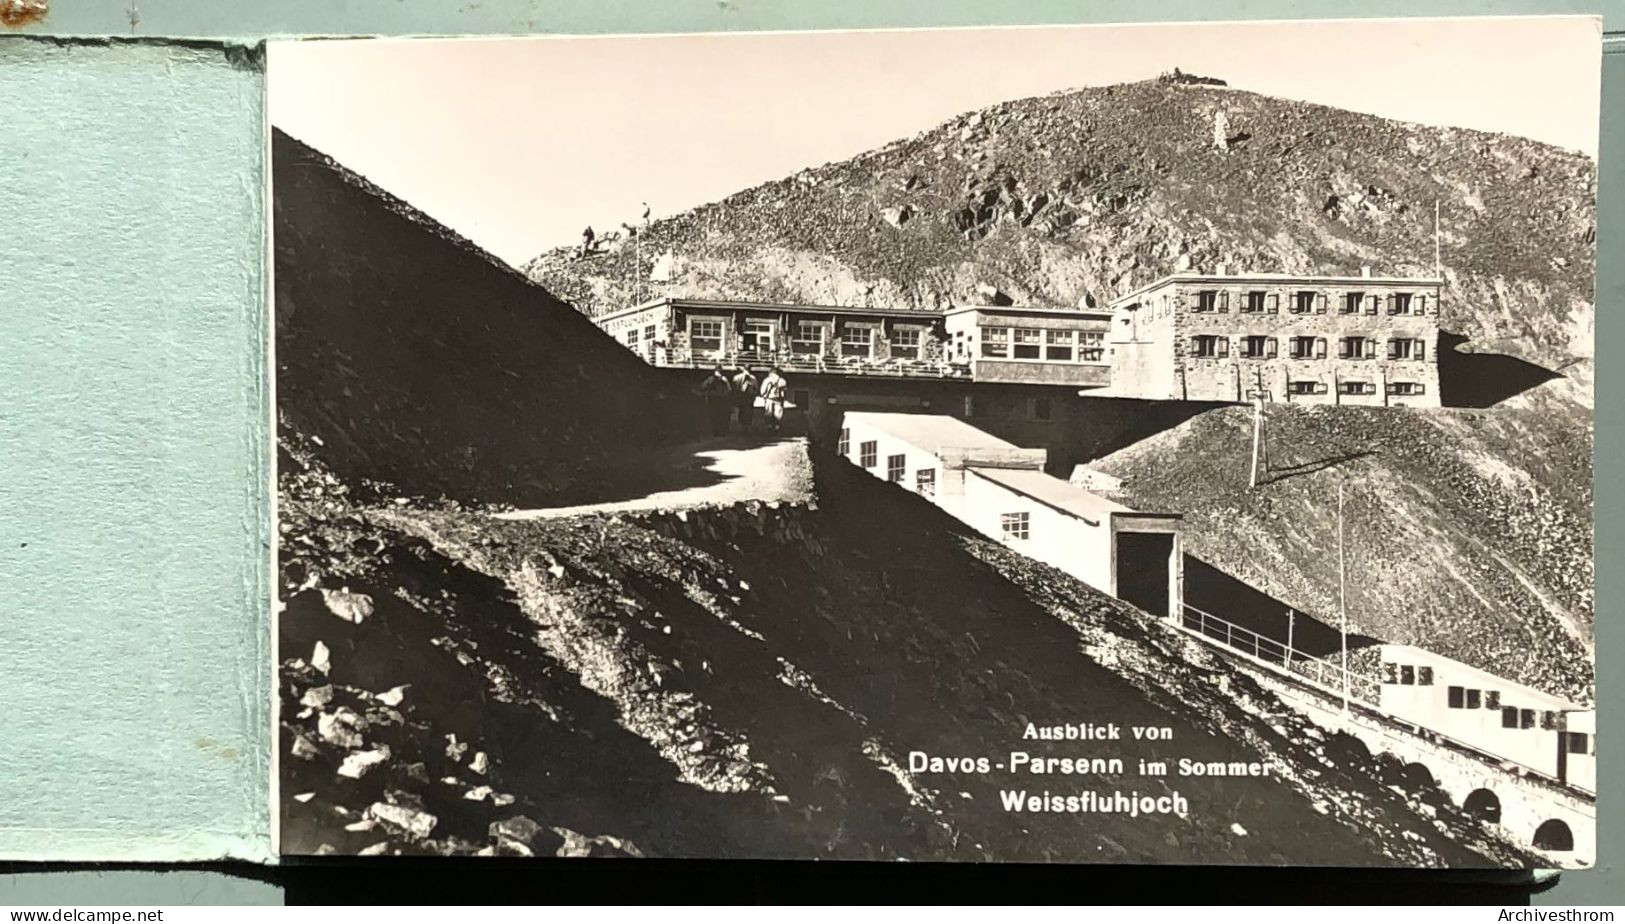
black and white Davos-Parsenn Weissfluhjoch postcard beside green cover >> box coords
[268,16,1601,869]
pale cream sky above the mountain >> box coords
[268,16,1602,265]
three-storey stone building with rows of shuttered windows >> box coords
[1107,271,1440,408]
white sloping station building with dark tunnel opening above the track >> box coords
[837,411,1183,617]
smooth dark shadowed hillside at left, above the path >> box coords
[273,132,697,507]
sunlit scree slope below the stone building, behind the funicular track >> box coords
[1094,406,1594,702]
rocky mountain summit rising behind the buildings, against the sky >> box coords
[525,78,1596,384]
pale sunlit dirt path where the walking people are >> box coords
[497,435,813,520]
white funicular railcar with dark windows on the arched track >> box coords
[1378,645,1597,792]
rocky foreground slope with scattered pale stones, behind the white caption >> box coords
[281,431,1529,866]
